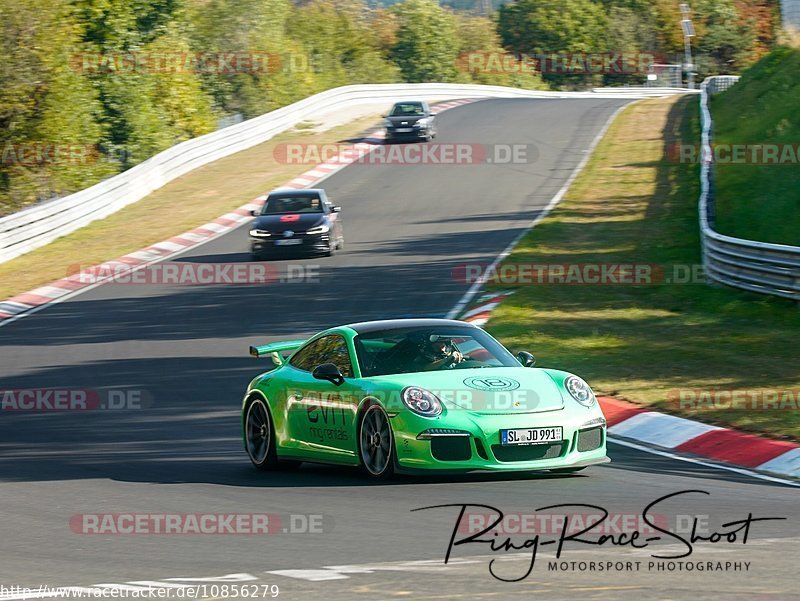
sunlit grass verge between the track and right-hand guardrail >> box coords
[487,96,800,440]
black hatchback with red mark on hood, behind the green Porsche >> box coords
[250,188,344,259]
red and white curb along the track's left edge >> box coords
[0,98,476,326]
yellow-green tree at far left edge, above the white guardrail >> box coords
[0,0,114,213]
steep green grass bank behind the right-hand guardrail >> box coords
[711,48,800,246]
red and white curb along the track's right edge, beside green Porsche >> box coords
[458,291,800,478]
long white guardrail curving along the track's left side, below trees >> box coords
[0,84,675,263]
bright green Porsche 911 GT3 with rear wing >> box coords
[242,319,609,478]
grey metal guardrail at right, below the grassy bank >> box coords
[699,75,800,300]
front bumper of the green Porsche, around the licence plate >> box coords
[391,405,610,472]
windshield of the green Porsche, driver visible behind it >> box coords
[354,326,520,377]
